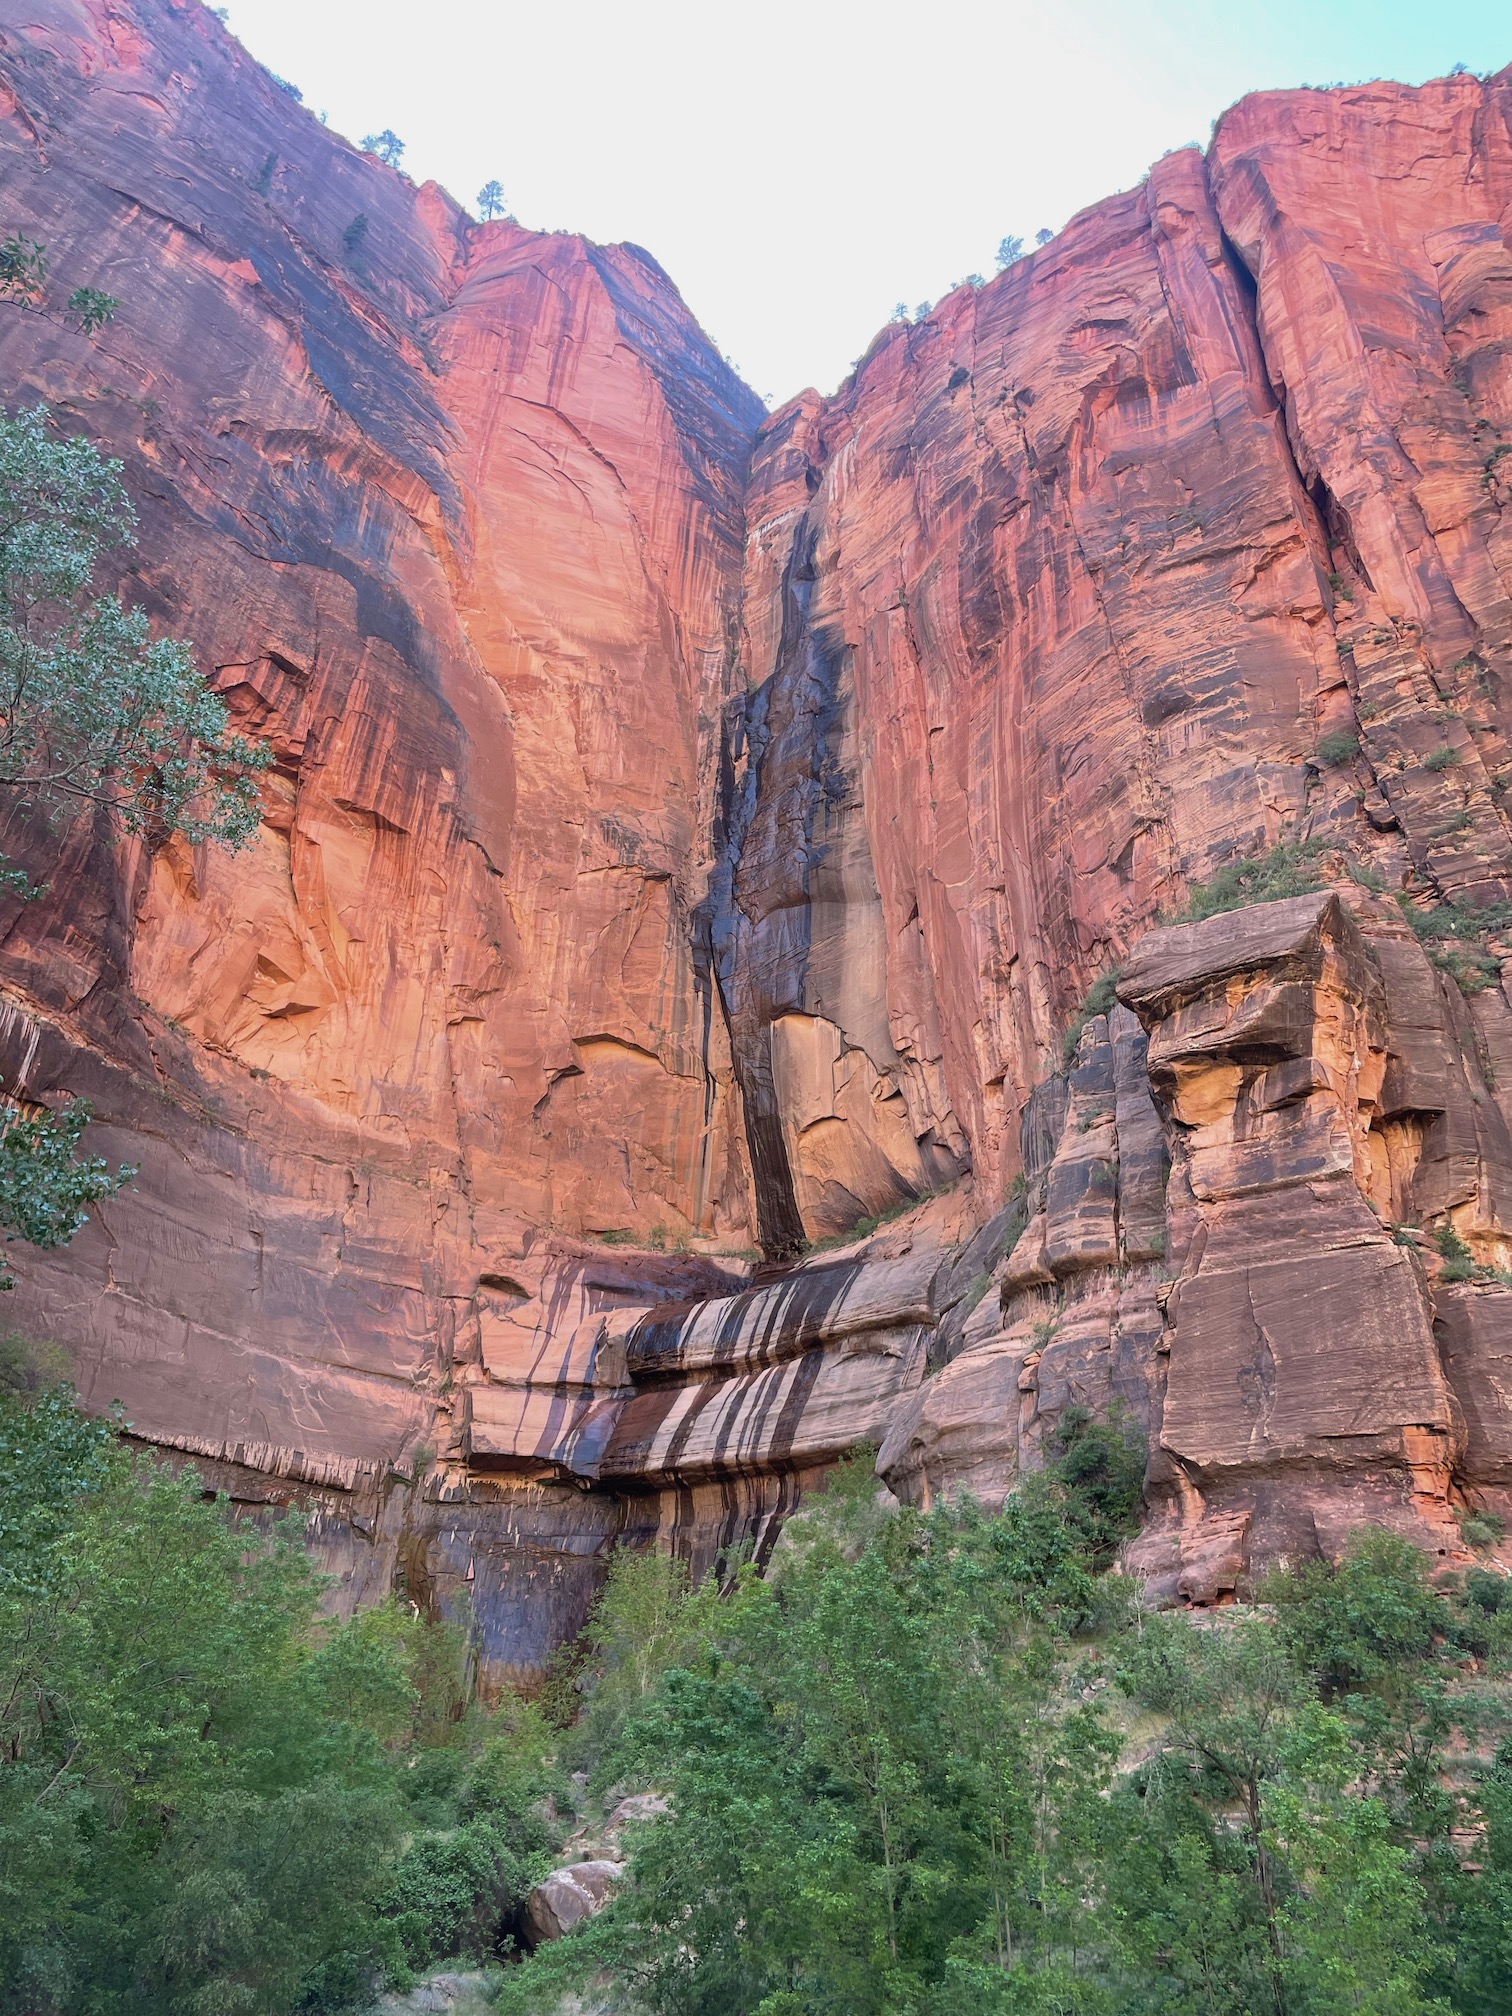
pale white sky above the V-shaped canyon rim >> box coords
[215,0,1512,403]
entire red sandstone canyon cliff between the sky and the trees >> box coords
[0,0,1512,1675]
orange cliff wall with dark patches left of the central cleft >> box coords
[0,0,760,1476]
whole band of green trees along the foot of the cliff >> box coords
[0,1343,1512,2016]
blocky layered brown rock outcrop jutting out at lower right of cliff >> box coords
[879,885,1512,1603]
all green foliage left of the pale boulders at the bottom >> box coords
[0,1349,556,2016]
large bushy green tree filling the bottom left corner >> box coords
[0,1387,431,2016]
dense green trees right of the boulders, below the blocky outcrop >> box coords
[500,1421,1512,2016]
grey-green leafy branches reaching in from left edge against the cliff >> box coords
[0,405,272,1288]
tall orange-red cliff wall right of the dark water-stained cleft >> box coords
[728,75,1512,1236]
